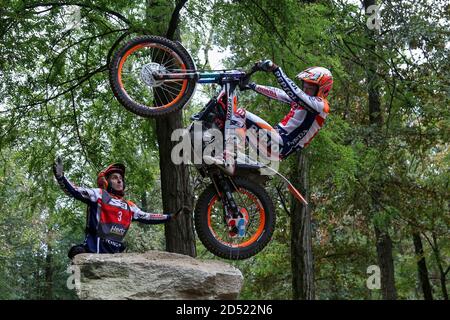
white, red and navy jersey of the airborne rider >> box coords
[249,67,329,158]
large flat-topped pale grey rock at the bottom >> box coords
[72,251,243,300]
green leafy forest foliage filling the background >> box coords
[0,0,450,299]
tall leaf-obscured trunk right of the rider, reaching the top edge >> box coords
[364,0,397,300]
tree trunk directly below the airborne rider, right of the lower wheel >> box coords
[291,151,315,300]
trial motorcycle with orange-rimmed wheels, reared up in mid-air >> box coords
[109,36,307,260]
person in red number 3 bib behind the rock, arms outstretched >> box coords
[53,157,181,259]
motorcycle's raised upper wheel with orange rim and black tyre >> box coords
[109,36,196,117]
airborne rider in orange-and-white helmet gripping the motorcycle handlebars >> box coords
[207,60,333,174]
